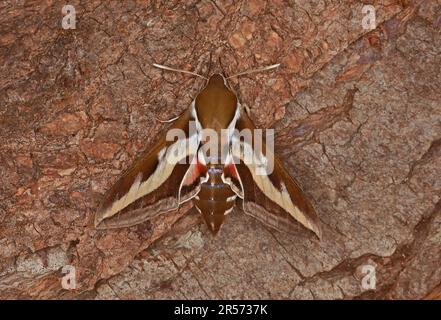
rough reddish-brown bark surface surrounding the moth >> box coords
[0,0,441,299]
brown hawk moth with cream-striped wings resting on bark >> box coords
[95,64,321,238]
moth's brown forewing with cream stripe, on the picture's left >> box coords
[95,110,199,229]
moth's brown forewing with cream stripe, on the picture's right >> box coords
[227,112,321,238]
